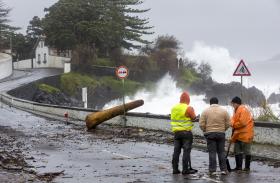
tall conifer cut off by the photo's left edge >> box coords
[0,0,18,49]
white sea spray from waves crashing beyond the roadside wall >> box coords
[104,42,279,114]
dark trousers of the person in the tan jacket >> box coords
[205,132,227,172]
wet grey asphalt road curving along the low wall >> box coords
[0,71,280,183]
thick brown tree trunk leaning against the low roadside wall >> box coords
[85,100,144,129]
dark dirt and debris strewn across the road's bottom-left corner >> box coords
[0,126,63,183]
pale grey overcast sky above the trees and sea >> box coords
[2,0,280,61]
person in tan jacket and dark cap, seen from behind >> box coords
[199,97,230,175]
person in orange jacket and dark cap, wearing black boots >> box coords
[231,97,254,171]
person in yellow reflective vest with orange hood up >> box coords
[171,92,197,174]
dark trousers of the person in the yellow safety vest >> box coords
[172,131,193,171]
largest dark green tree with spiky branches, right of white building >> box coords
[43,0,152,59]
